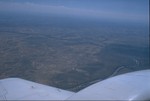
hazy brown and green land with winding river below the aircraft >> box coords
[0,13,150,91]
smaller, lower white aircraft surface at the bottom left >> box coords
[0,78,74,100]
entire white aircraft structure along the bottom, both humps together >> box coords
[0,70,150,101]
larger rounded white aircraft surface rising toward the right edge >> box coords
[68,70,150,101]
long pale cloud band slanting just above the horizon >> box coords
[0,2,148,20]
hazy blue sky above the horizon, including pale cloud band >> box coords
[0,0,149,22]
